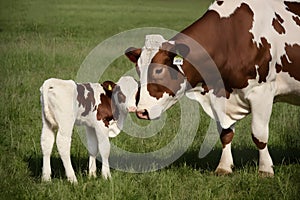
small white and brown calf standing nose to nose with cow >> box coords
[40,76,138,183]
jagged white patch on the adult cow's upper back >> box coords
[248,0,300,69]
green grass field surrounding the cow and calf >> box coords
[0,0,300,200]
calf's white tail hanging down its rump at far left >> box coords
[40,79,57,128]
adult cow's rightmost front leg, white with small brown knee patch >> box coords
[249,85,274,176]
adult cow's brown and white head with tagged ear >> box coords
[125,35,189,119]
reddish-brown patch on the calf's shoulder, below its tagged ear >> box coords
[97,94,113,127]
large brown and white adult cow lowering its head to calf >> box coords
[125,0,300,176]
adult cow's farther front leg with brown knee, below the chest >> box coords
[215,126,234,175]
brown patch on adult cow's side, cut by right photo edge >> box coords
[276,44,300,81]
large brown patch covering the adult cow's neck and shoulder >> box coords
[174,3,272,98]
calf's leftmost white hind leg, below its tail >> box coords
[41,117,55,181]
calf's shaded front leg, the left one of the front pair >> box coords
[86,127,98,177]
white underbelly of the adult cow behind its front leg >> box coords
[274,72,300,105]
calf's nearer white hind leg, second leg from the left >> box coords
[56,126,77,183]
